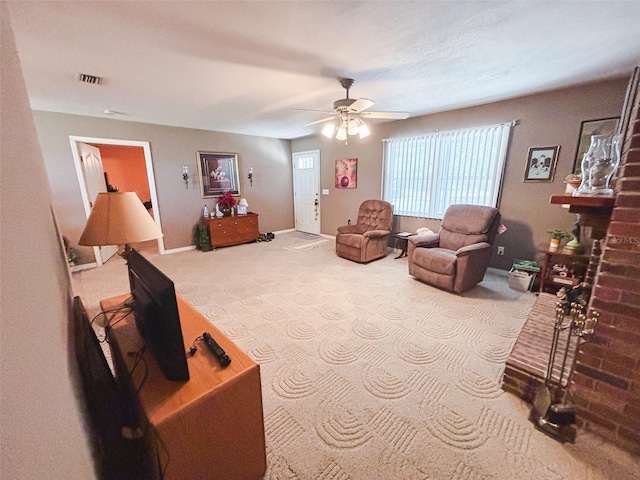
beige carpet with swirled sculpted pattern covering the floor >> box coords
[74,233,640,480]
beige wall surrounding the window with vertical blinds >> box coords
[292,78,628,269]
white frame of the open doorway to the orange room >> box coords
[69,135,165,266]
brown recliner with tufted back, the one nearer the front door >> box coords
[336,200,393,263]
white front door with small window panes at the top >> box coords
[293,150,320,235]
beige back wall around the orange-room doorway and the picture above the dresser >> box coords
[33,111,293,263]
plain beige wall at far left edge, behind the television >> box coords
[0,2,95,480]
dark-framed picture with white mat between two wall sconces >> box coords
[197,151,240,198]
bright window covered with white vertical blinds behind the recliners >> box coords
[382,123,512,218]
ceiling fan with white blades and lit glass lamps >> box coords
[296,78,409,143]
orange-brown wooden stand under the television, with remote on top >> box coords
[100,295,267,480]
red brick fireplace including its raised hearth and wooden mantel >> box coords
[503,69,640,454]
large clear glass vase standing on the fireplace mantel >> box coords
[573,134,622,197]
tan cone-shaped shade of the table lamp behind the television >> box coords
[78,192,163,246]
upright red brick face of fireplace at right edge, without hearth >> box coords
[570,69,640,453]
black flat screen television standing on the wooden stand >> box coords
[127,250,189,382]
